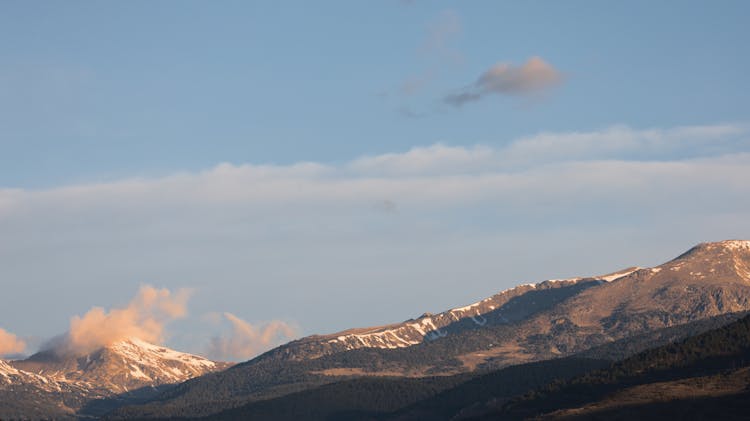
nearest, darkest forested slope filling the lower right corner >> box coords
[464,317,750,420]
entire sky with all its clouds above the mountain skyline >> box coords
[0,0,750,360]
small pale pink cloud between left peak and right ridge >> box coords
[207,313,299,361]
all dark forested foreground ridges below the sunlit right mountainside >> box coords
[122,310,750,421]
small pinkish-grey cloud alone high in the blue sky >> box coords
[444,57,563,107]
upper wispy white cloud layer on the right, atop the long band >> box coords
[347,124,750,176]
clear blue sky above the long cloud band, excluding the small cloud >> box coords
[0,1,750,187]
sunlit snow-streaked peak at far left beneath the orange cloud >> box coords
[0,338,229,419]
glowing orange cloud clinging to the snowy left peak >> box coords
[46,285,190,355]
